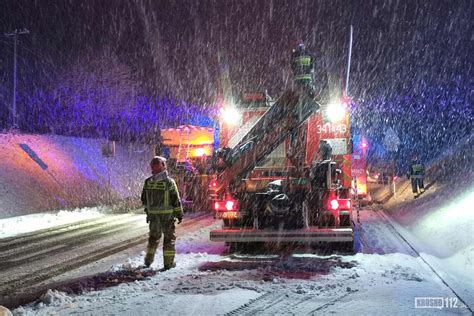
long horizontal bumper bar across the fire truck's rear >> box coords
[210,228,354,243]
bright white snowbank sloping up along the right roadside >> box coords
[385,137,474,306]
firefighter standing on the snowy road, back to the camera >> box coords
[141,156,183,270]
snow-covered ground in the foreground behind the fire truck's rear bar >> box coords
[9,210,471,315]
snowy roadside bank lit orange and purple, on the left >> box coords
[0,134,151,218]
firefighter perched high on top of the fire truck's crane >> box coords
[291,44,315,98]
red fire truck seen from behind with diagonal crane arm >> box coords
[210,90,354,249]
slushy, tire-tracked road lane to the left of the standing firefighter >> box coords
[0,213,209,305]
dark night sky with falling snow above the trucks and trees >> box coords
[0,0,473,163]
